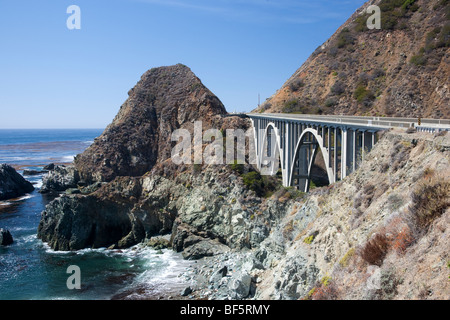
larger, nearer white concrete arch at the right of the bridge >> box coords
[288,128,335,192]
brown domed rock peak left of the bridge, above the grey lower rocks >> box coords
[75,64,226,183]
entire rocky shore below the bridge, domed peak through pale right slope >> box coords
[33,65,450,300]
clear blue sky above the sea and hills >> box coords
[0,0,365,128]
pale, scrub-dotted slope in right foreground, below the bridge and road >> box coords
[182,131,450,300]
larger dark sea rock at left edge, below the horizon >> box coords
[0,164,34,200]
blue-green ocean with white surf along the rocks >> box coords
[0,129,190,300]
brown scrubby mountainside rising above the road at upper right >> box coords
[255,0,450,118]
